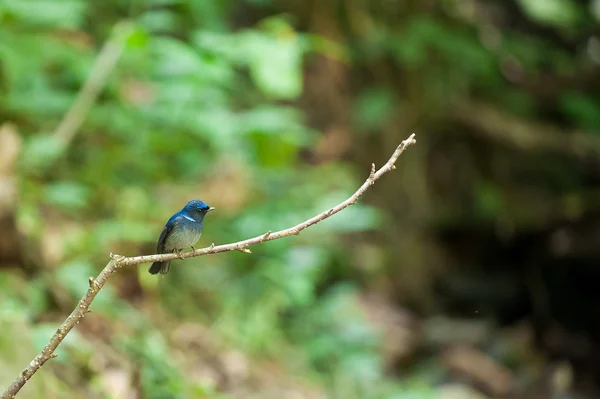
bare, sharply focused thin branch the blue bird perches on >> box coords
[2,134,416,399]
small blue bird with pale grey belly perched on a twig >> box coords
[148,199,215,274]
